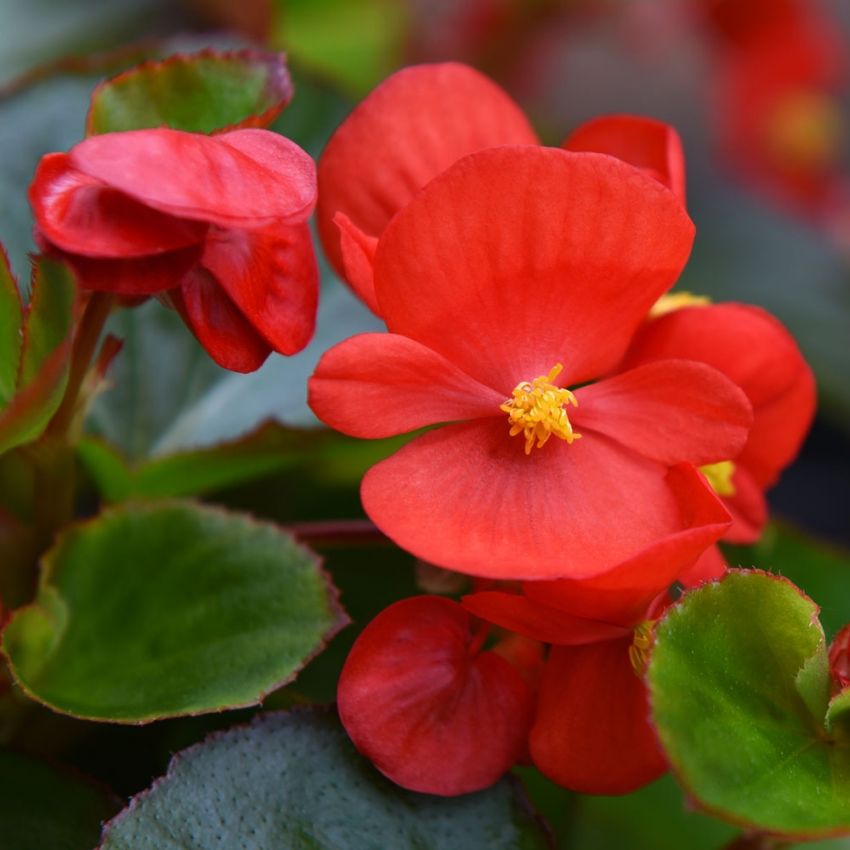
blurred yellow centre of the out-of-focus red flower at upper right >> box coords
[763,89,844,171]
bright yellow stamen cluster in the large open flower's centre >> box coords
[499,363,581,455]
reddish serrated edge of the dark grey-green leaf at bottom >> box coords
[95,703,558,850]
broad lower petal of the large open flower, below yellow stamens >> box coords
[361,420,728,580]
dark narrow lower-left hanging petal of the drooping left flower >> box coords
[174,266,271,372]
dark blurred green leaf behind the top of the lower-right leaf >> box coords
[723,523,850,637]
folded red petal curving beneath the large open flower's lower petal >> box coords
[523,464,729,627]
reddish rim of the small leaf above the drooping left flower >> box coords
[85,47,295,137]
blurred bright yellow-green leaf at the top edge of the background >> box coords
[270,0,409,96]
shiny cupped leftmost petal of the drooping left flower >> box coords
[29,153,207,258]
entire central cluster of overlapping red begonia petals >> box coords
[310,64,814,794]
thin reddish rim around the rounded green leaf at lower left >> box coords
[0,499,352,726]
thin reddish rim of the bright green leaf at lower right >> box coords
[644,567,850,842]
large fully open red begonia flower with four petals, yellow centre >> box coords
[310,146,751,579]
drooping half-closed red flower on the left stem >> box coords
[30,129,318,372]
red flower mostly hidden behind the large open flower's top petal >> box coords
[317,62,684,316]
